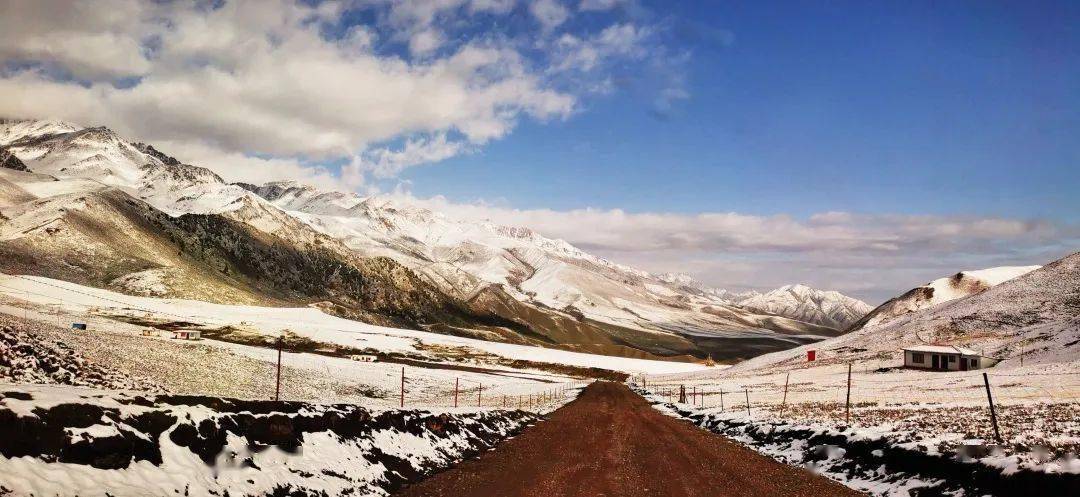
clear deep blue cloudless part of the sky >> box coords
[402,1,1080,221]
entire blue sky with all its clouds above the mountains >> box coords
[0,0,1080,304]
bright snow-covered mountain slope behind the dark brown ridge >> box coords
[238,183,851,358]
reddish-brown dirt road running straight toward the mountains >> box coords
[395,382,863,497]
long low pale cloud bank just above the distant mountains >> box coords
[384,192,1080,304]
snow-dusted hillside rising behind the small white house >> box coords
[732,252,1080,372]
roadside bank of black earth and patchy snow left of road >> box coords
[0,386,539,497]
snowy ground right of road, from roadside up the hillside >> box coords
[636,253,1080,495]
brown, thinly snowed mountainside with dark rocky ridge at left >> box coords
[0,170,533,337]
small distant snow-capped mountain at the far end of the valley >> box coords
[738,284,873,330]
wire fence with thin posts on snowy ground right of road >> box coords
[632,364,1080,443]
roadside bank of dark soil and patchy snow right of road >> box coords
[638,388,1080,497]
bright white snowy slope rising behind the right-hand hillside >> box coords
[850,266,1039,330]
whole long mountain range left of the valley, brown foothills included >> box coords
[0,120,870,361]
